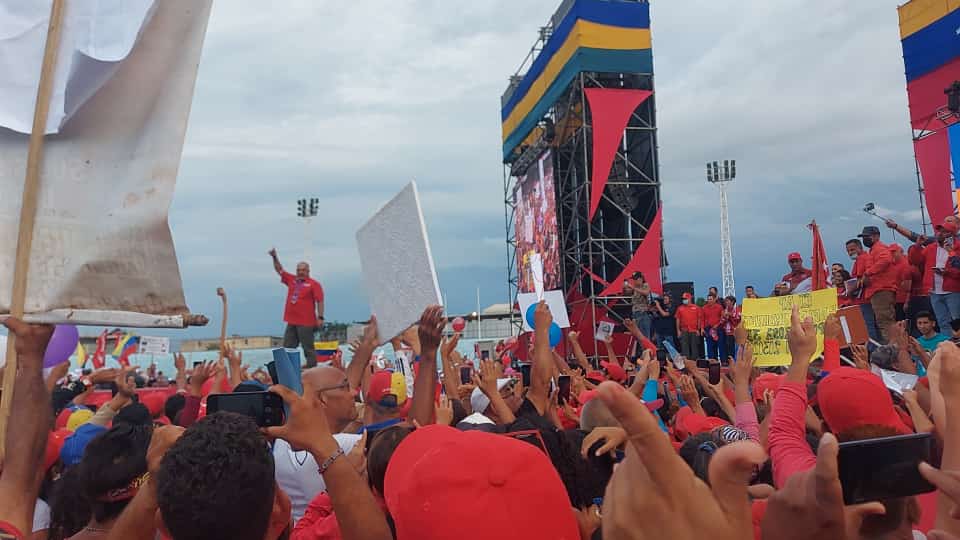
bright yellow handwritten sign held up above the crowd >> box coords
[743,288,837,367]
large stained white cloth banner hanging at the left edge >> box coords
[0,0,211,326]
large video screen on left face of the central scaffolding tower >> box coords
[513,150,560,292]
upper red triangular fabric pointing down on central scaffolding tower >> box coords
[584,88,653,221]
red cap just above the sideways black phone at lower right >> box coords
[817,367,913,435]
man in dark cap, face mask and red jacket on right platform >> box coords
[856,226,898,343]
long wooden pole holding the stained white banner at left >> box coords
[0,0,65,461]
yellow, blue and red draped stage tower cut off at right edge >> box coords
[898,0,960,232]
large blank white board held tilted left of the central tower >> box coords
[357,182,443,344]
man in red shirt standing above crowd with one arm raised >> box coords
[270,249,324,368]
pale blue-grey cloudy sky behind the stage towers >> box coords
[170,0,920,335]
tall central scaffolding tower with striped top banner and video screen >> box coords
[501,0,665,355]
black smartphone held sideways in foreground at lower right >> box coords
[837,433,936,505]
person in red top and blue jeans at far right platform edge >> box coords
[907,221,960,336]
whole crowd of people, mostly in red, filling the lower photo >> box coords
[0,220,960,540]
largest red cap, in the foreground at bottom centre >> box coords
[384,425,580,540]
